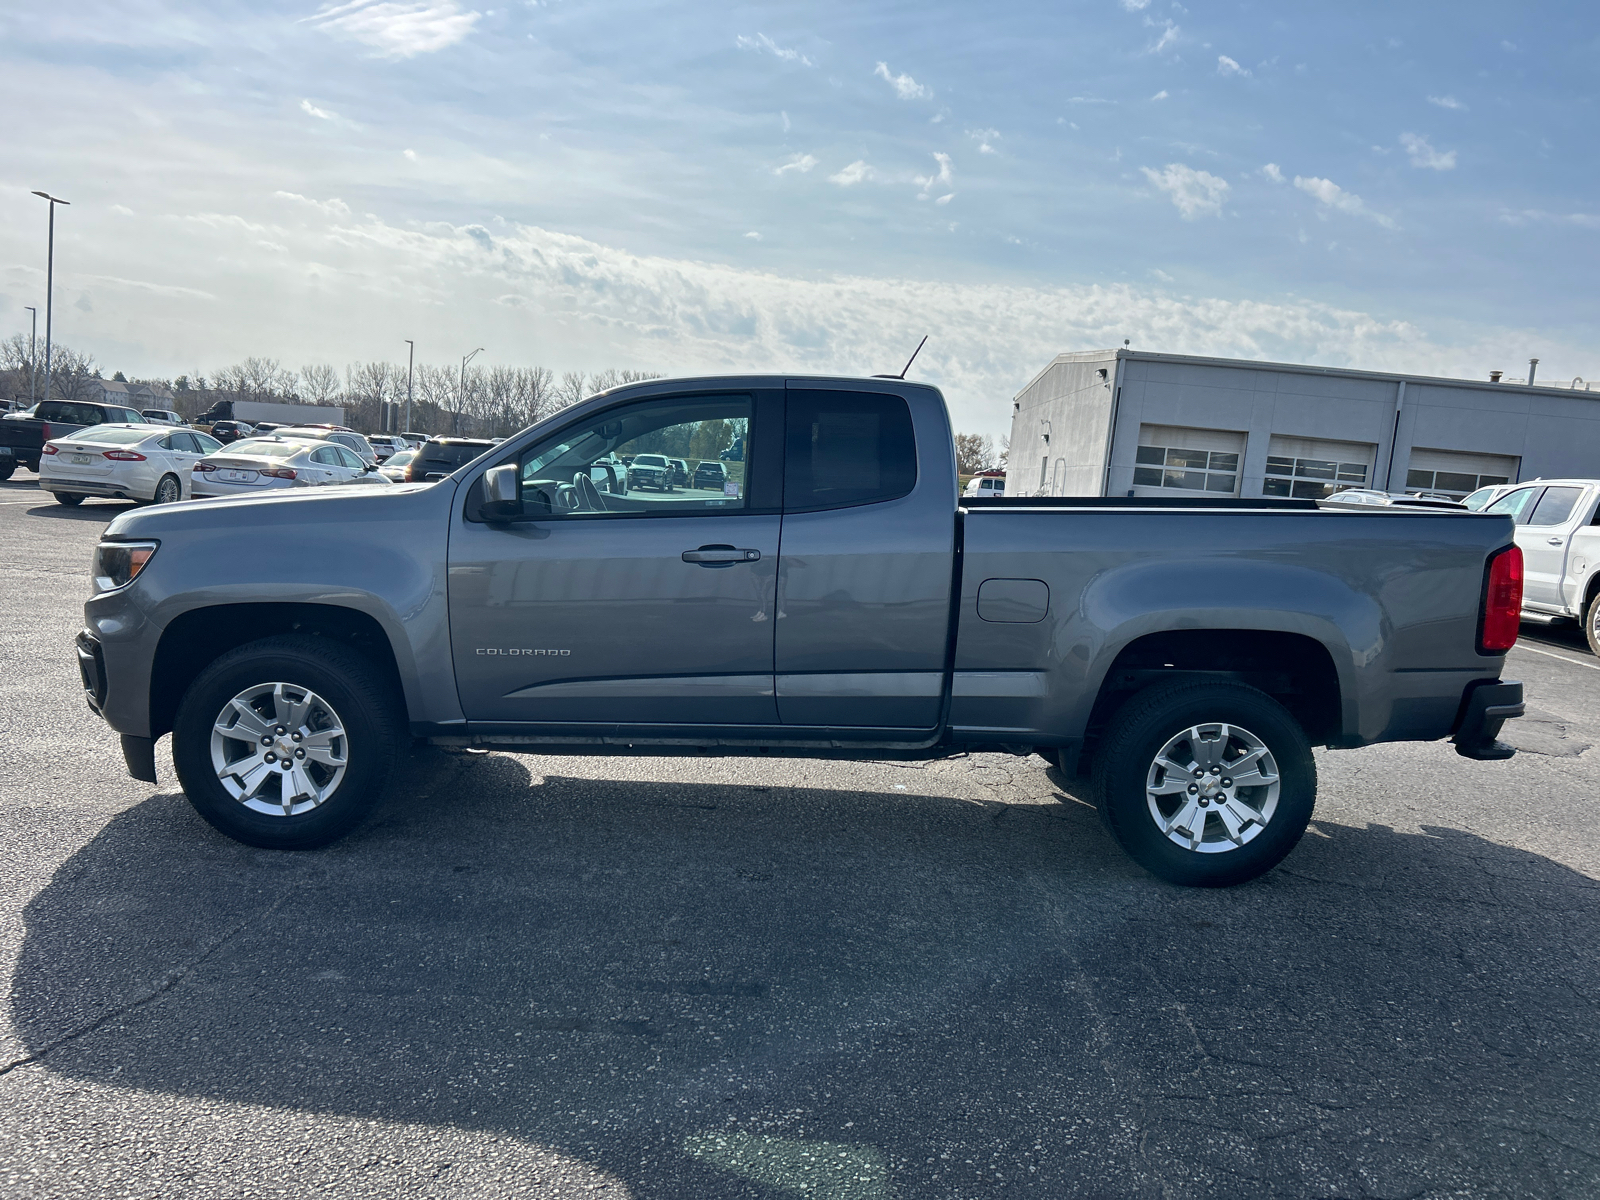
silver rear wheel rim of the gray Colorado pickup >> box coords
[1144,722,1280,854]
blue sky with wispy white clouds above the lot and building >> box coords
[0,0,1600,432]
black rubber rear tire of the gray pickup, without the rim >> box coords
[1094,682,1317,888]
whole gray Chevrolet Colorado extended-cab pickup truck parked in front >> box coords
[77,376,1522,885]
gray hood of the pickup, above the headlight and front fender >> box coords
[106,480,456,539]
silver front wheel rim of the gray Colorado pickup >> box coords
[211,683,349,816]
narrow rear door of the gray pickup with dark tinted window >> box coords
[776,381,955,730]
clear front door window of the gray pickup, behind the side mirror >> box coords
[502,395,752,520]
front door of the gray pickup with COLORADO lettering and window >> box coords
[448,390,782,733]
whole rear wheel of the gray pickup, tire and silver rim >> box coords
[1094,682,1317,888]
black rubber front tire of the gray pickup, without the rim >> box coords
[173,635,406,850]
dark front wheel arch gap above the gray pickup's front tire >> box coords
[150,603,405,738]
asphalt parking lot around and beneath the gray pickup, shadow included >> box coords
[0,472,1600,1200]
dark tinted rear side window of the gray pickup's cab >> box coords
[784,390,917,512]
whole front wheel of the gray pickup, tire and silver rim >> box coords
[173,635,403,850]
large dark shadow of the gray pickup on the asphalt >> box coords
[11,752,1600,1198]
